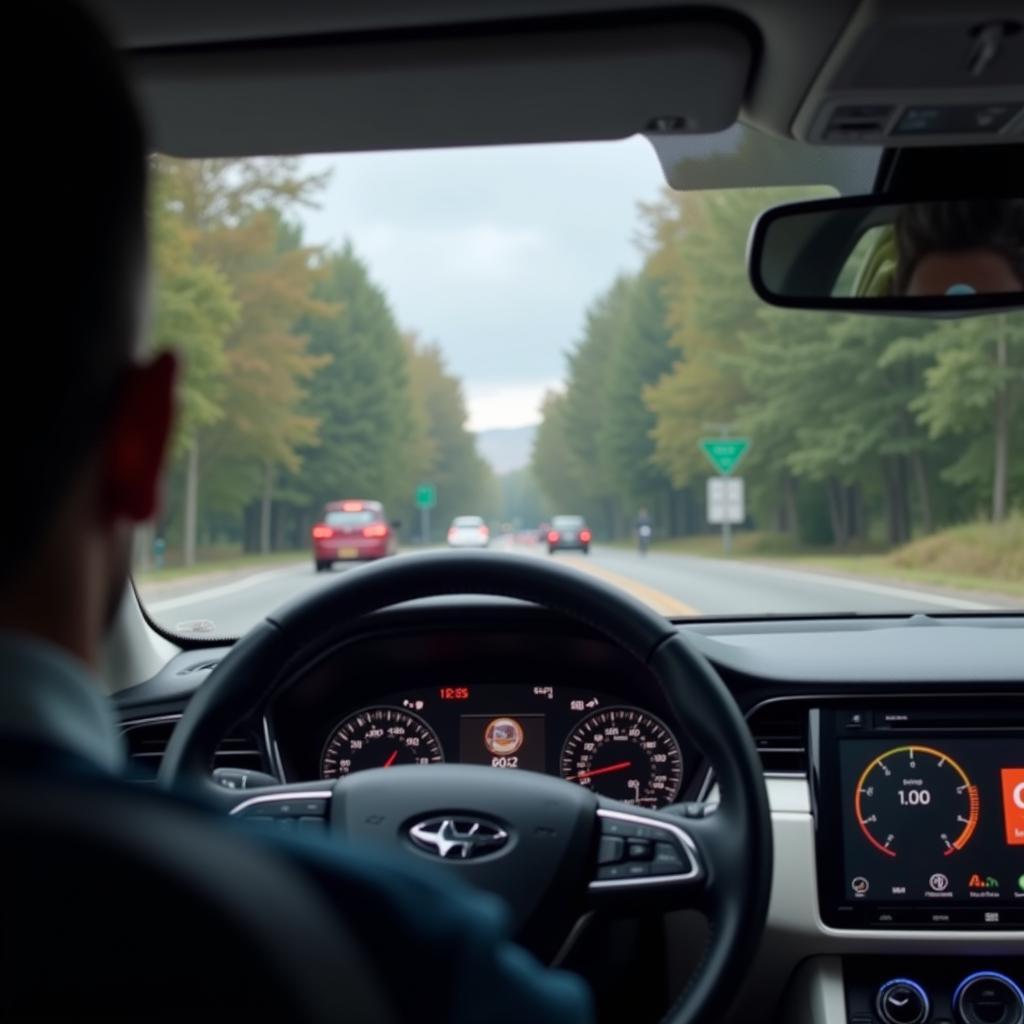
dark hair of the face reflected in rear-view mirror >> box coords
[894,199,1024,295]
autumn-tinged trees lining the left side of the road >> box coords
[146,157,499,565]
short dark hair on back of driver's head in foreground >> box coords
[0,6,146,582]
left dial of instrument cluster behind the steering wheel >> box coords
[321,708,444,778]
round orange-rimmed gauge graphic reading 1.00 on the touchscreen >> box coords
[855,745,979,857]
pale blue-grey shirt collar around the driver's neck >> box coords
[0,632,124,772]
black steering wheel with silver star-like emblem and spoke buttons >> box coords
[160,552,772,1024]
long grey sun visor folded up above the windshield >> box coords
[127,17,753,157]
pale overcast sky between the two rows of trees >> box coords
[303,137,664,430]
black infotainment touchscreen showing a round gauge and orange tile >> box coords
[817,709,1024,928]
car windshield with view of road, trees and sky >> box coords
[135,138,1024,636]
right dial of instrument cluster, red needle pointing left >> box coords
[559,708,683,807]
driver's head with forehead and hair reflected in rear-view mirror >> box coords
[895,200,1024,297]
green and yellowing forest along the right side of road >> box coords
[532,188,1024,547]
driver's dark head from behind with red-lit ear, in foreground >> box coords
[0,2,174,660]
